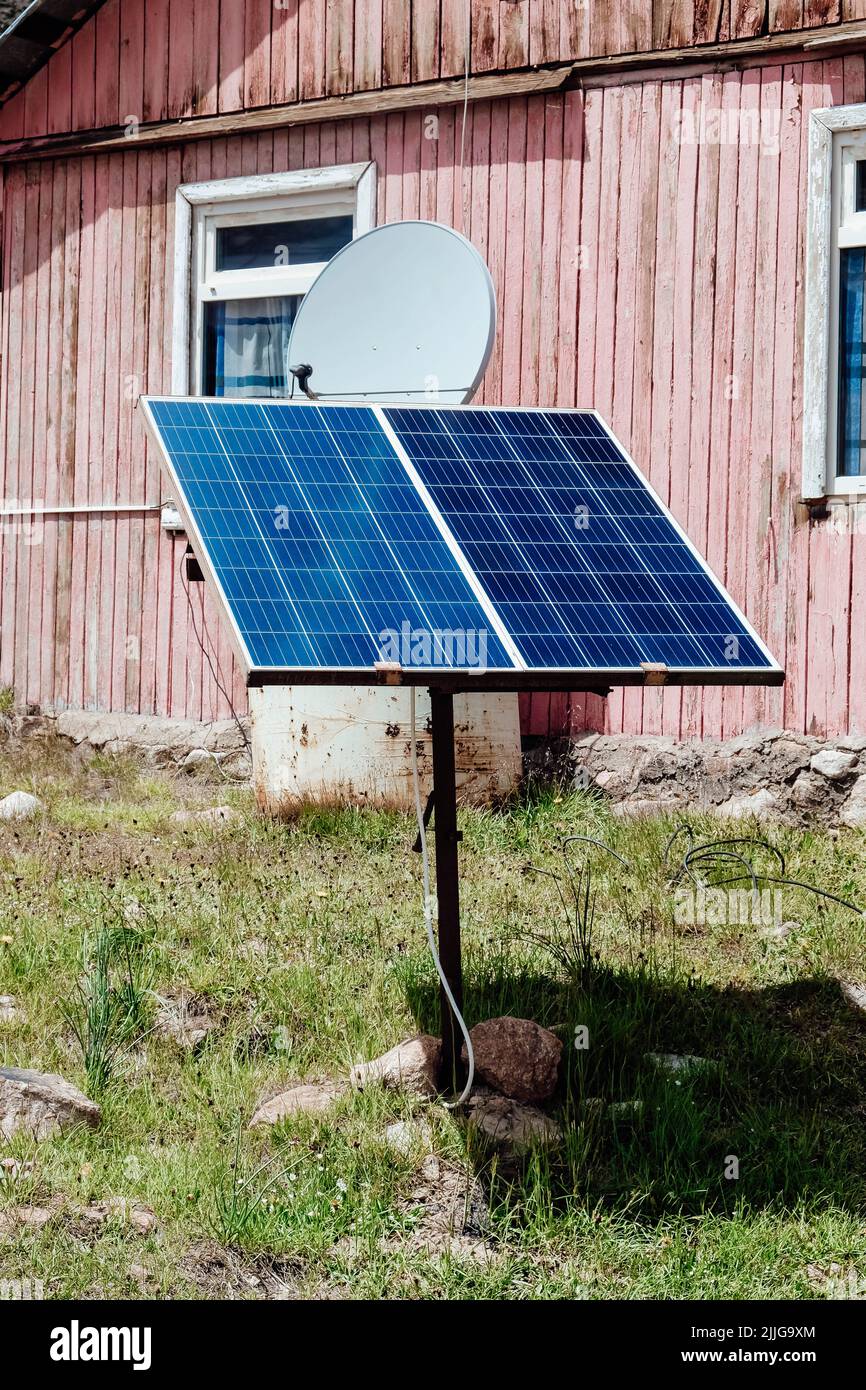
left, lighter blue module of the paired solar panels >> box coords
[149,399,513,670]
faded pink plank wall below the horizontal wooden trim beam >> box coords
[0,57,866,735]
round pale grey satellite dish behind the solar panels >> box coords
[289,221,496,404]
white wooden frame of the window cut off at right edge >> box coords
[802,103,866,503]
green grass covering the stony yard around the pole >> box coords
[0,744,866,1300]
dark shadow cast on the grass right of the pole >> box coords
[403,956,866,1220]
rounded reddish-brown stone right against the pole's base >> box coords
[463,1015,563,1102]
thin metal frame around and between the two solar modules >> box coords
[139,396,784,694]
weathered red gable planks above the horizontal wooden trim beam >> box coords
[0,0,866,139]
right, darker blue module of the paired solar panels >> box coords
[382,406,781,682]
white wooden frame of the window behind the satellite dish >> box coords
[171,161,375,396]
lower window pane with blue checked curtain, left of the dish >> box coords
[204,295,300,396]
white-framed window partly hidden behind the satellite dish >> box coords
[172,164,375,396]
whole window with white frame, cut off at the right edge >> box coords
[802,106,866,500]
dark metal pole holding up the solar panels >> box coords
[430,689,463,1091]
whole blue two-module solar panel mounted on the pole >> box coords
[143,398,783,688]
